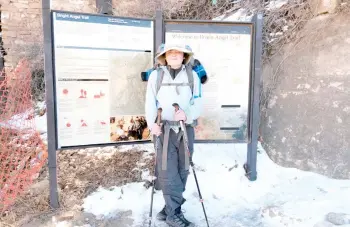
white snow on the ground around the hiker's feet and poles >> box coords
[71,144,350,227]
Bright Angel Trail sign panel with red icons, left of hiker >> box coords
[52,11,154,148]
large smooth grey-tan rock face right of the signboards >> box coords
[261,13,350,179]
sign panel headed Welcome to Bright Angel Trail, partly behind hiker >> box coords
[165,21,253,142]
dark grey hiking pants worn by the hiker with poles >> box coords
[153,126,195,216]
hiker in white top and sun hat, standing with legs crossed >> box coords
[145,44,202,227]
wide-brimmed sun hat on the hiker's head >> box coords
[155,44,194,65]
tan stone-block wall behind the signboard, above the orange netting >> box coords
[0,0,96,68]
